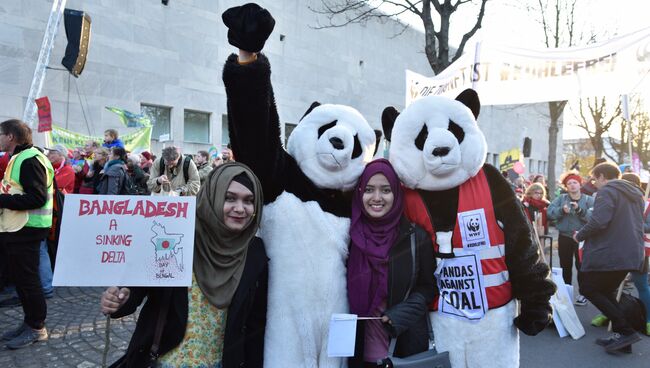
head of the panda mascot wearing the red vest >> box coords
[382,89,487,191]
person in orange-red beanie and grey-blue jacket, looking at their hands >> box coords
[547,171,594,305]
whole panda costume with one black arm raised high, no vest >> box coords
[223,4,379,368]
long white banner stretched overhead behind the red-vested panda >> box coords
[405,27,650,106]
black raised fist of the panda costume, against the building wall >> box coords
[221,3,275,52]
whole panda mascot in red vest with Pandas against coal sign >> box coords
[382,89,555,368]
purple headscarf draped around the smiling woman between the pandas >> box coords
[348,158,404,316]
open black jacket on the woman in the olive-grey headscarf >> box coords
[111,238,268,368]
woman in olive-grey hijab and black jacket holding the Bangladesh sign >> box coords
[101,162,268,368]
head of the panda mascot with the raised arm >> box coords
[287,102,381,191]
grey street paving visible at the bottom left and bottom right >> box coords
[0,243,650,368]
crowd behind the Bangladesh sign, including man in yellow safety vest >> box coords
[0,119,232,349]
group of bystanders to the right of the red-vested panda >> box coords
[511,159,650,352]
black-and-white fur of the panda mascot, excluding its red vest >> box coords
[382,90,555,368]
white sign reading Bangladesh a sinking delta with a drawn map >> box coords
[53,194,196,286]
